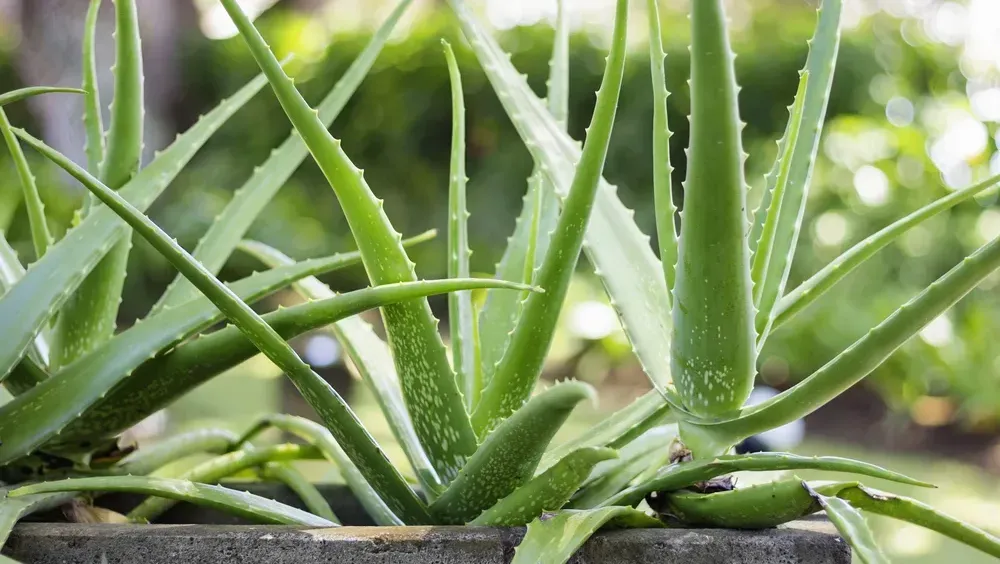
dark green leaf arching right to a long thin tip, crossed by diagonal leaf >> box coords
[56,279,525,453]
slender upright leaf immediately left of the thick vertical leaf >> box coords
[646,0,677,298]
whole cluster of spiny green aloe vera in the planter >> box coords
[0,0,1000,563]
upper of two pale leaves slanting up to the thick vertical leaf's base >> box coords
[538,390,670,471]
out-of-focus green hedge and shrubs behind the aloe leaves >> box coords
[0,3,1000,427]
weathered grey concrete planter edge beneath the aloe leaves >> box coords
[4,484,851,564]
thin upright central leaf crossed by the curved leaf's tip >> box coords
[441,39,478,410]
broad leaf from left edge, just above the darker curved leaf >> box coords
[0,223,372,463]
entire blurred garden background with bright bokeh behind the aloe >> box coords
[0,0,1000,562]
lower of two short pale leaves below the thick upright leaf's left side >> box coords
[568,425,677,509]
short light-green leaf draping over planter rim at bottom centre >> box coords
[511,507,663,564]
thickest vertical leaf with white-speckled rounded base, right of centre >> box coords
[670,0,757,424]
